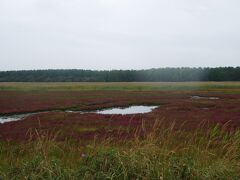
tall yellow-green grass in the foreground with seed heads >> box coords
[0,122,240,179]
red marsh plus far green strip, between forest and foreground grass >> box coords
[0,82,240,140]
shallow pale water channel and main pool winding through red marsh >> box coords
[0,106,158,124]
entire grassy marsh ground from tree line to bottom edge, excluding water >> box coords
[0,82,240,179]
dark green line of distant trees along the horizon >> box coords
[0,67,240,82]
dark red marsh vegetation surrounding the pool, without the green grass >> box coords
[0,85,240,141]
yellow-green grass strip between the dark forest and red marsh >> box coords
[0,82,240,94]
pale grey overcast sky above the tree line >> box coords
[0,0,240,70]
